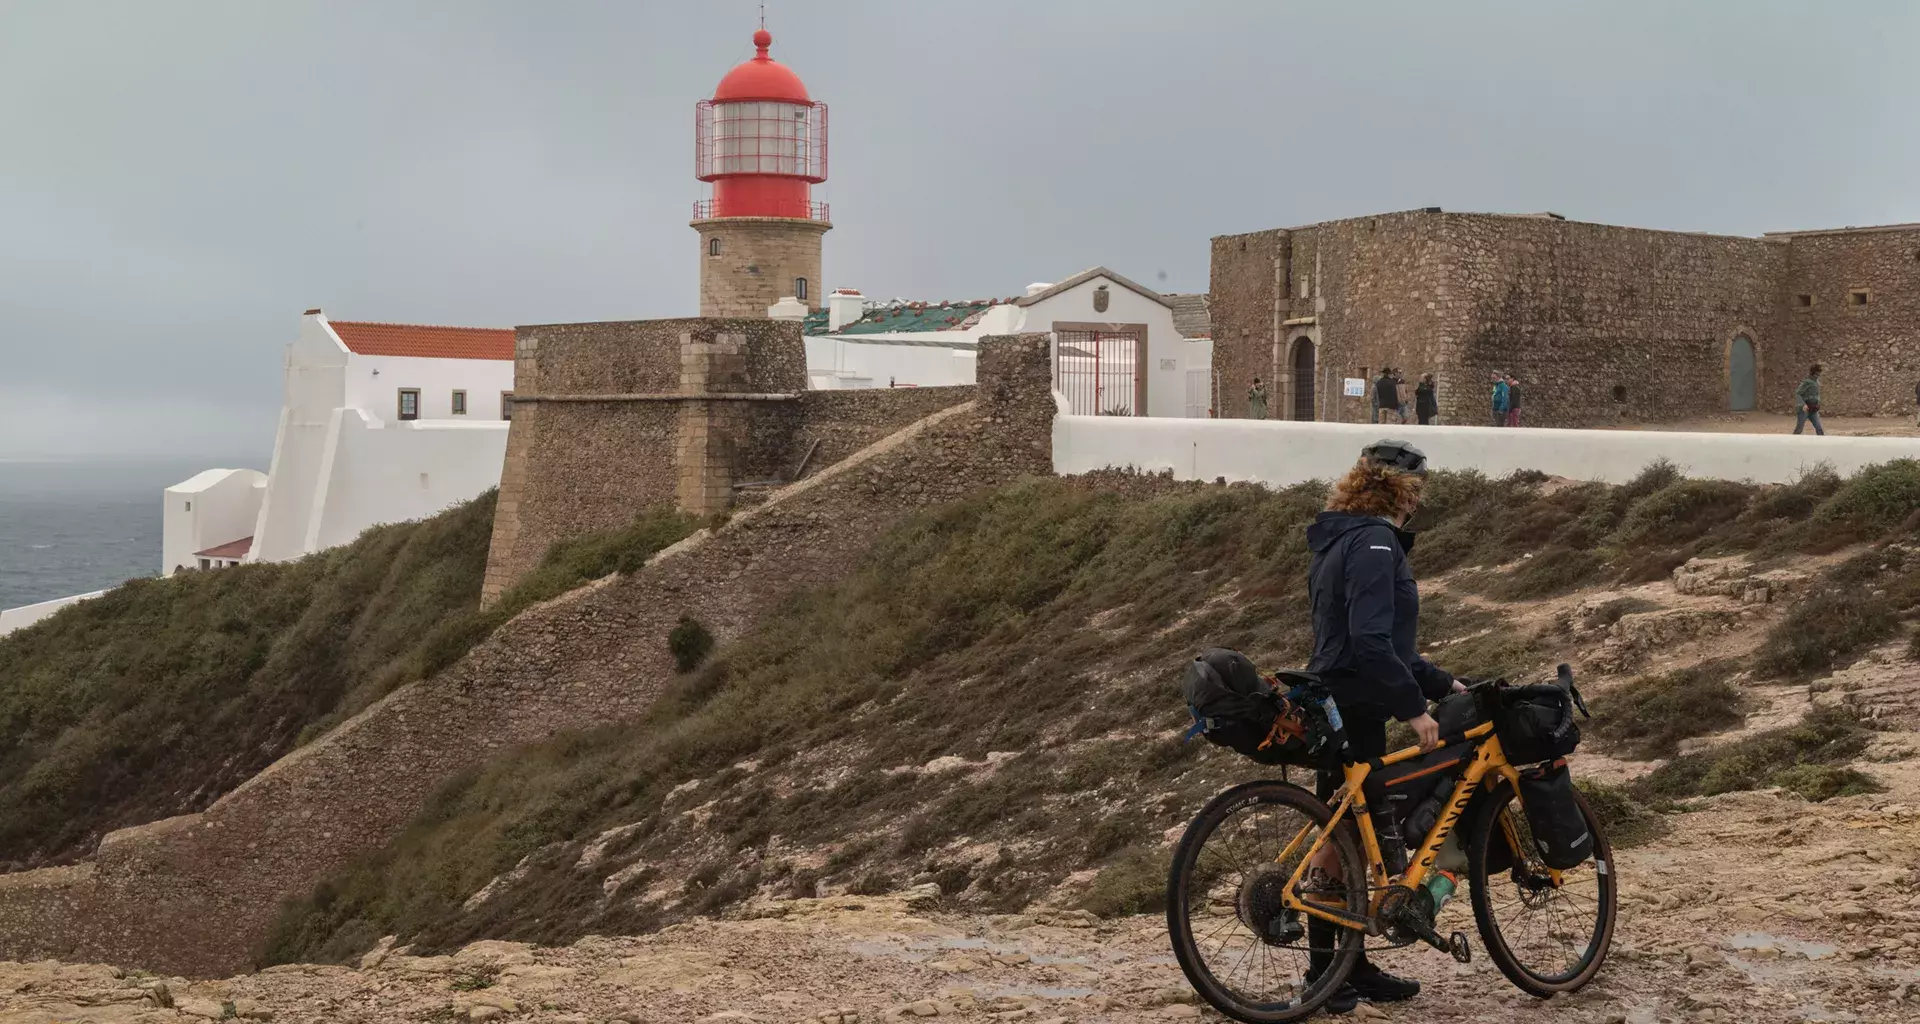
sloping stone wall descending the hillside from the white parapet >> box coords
[0,334,1054,976]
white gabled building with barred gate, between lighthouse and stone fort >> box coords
[768,267,1213,417]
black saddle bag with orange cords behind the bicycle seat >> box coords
[1181,647,1329,768]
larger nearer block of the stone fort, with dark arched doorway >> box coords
[1212,211,1781,427]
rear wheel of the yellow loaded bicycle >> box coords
[1167,780,1367,1024]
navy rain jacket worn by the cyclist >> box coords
[1308,511,1453,722]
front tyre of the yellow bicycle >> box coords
[1467,780,1619,999]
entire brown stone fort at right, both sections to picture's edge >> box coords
[1210,209,1920,427]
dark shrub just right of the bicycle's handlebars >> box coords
[1590,661,1745,761]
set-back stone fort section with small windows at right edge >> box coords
[1766,227,1920,415]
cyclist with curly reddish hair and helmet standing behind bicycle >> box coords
[1308,440,1465,1014]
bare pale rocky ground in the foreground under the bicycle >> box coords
[11,745,1920,1024]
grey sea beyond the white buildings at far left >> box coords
[0,455,267,609]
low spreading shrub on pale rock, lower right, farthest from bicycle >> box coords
[1630,707,1872,799]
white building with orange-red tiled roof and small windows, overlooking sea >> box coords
[246,309,513,561]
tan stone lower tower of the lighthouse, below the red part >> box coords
[693,217,833,317]
